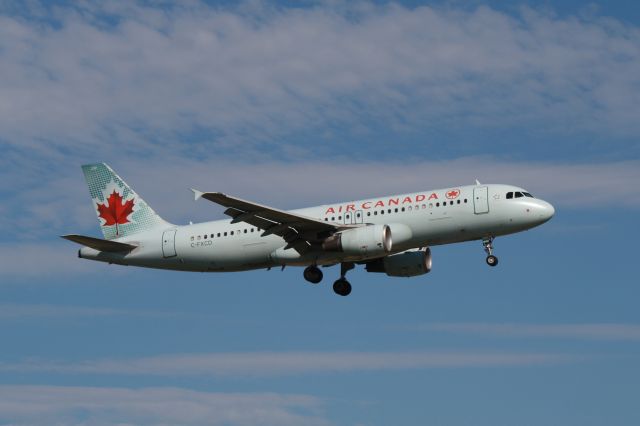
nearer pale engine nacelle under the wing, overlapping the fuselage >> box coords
[322,225,392,256]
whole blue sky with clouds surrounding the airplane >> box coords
[0,1,640,426]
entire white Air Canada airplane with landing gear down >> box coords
[62,163,555,296]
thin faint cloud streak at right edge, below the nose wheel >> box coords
[416,323,640,341]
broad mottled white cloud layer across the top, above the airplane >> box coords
[0,1,640,158]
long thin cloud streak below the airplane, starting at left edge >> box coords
[0,351,574,376]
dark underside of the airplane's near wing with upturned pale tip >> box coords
[192,189,357,254]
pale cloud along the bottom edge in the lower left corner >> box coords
[0,385,329,426]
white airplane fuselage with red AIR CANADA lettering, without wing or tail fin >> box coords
[79,185,554,272]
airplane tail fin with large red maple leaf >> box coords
[82,163,170,240]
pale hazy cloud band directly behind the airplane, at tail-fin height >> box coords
[0,157,640,243]
